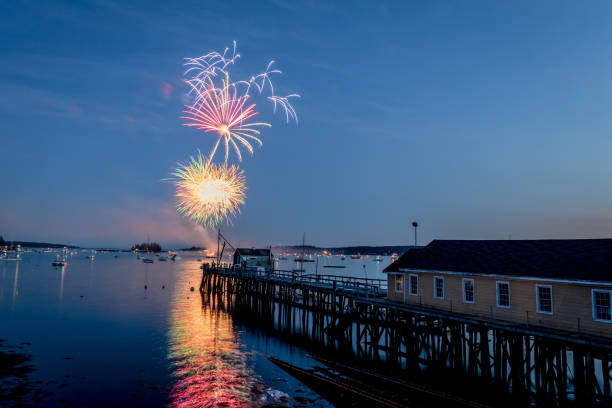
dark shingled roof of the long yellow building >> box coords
[384,239,612,282]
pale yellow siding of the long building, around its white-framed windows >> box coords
[388,272,612,337]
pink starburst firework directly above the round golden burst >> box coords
[181,74,271,164]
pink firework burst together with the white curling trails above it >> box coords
[181,41,299,165]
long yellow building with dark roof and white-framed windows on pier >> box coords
[384,239,612,337]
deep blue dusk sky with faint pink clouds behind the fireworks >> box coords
[0,0,612,247]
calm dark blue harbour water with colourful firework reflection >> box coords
[0,252,344,407]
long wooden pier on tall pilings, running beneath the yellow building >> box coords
[200,264,612,406]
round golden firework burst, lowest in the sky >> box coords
[173,153,246,228]
